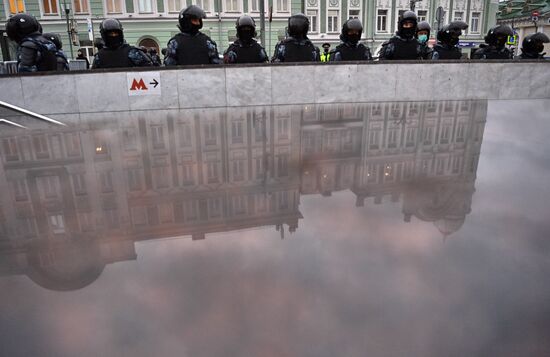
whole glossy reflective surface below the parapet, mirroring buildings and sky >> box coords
[0,101,550,357]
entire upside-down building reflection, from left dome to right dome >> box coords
[0,101,486,290]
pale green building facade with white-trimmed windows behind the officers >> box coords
[0,0,498,60]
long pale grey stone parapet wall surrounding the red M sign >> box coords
[0,62,550,114]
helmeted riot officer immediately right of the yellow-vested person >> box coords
[330,19,372,61]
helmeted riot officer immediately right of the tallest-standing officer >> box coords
[223,15,269,63]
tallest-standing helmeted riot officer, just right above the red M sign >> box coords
[164,5,221,66]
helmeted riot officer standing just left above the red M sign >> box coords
[92,19,152,69]
